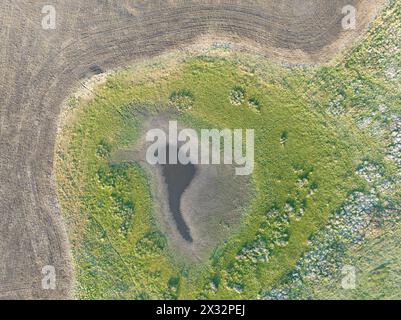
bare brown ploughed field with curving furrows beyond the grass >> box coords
[0,0,385,299]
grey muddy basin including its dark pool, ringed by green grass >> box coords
[112,112,253,261]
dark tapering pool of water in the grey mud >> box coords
[162,147,196,242]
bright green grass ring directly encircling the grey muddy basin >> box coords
[57,53,368,298]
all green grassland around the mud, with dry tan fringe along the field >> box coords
[55,2,401,299]
